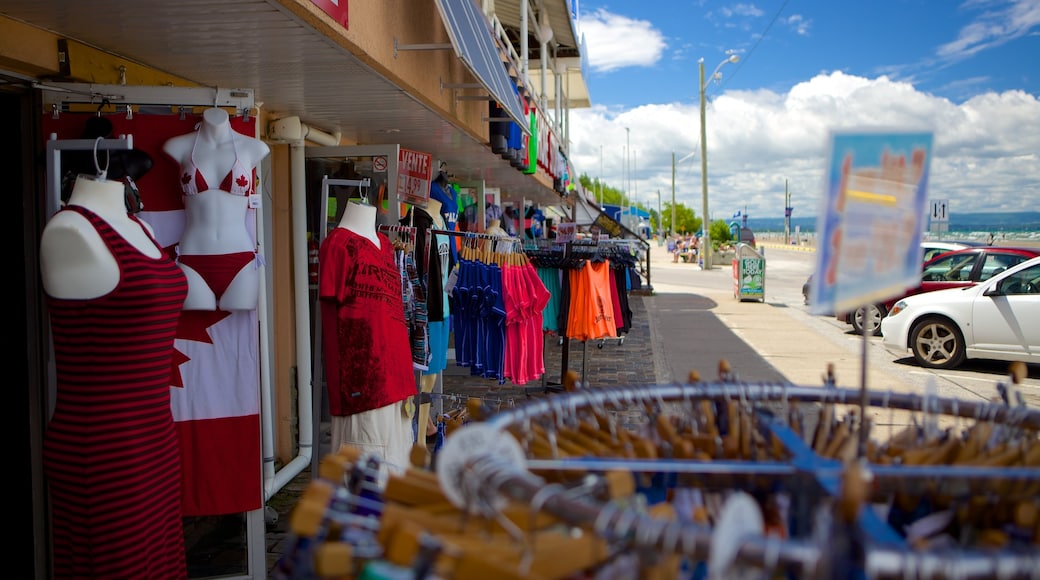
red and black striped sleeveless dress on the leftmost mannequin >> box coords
[44,206,187,579]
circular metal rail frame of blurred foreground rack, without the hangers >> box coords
[430,379,1040,579]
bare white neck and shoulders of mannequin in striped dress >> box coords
[40,176,162,299]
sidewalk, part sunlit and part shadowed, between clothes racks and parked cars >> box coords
[644,244,910,392]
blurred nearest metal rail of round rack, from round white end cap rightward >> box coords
[438,432,1040,580]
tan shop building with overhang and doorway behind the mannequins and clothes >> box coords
[0,0,590,578]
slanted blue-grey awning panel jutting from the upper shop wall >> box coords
[437,0,530,134]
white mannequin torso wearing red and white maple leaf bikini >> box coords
[162,108,270,311]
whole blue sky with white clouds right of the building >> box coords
[570,0,1040,225]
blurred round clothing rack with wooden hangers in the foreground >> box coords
[287,372,1040,580]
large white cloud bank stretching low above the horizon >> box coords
[570,72,1040,218]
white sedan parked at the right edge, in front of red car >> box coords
[881,258,1040,369]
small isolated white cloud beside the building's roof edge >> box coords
[581,9,668,73]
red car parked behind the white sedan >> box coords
[837,245,1040,336]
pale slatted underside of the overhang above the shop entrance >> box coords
[0,0,574,204]
